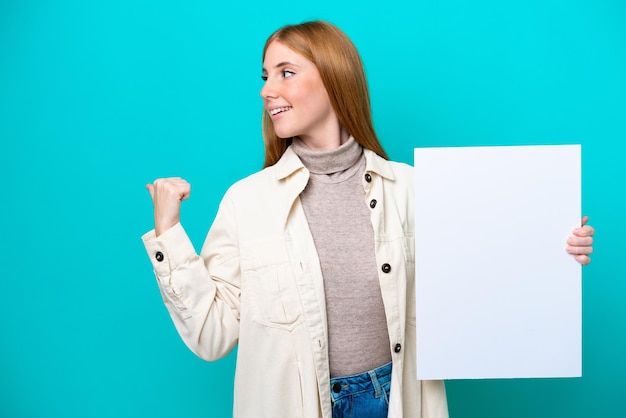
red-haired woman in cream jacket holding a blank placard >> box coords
[143,21,593,418]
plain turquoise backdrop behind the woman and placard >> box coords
[0,0,626,418]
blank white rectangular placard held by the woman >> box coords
[415,145,582,380]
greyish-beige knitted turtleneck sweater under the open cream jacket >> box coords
[292,137,391,377]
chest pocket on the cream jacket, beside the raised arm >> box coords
[240,237,302,330]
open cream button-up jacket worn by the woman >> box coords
[143,148,448,418]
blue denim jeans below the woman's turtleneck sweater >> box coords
[330,362,391,418]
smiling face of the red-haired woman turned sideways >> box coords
[261,41,341,149]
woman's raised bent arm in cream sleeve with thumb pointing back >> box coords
[142,177,241,360]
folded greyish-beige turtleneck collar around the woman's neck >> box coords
[291,136,363,174]
